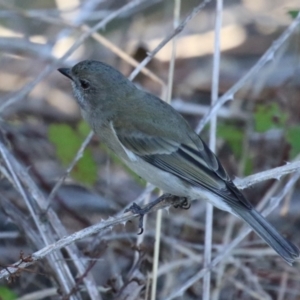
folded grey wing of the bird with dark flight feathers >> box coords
[117,130,252,209]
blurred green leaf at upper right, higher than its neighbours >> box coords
[254,103,287,132]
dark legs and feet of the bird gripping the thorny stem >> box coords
[125,194,191,234]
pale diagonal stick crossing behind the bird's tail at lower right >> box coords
[166,172,300,300]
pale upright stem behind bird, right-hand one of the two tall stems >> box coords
[202,0,223,300]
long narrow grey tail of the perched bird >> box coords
[235,208,300,265]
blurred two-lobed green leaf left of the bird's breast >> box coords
[48,124,97,185]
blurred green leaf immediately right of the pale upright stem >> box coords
[217,123,244,158]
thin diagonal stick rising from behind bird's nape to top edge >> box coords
[128,0,210,80]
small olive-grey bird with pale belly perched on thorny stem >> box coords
[58,60,299,264]
